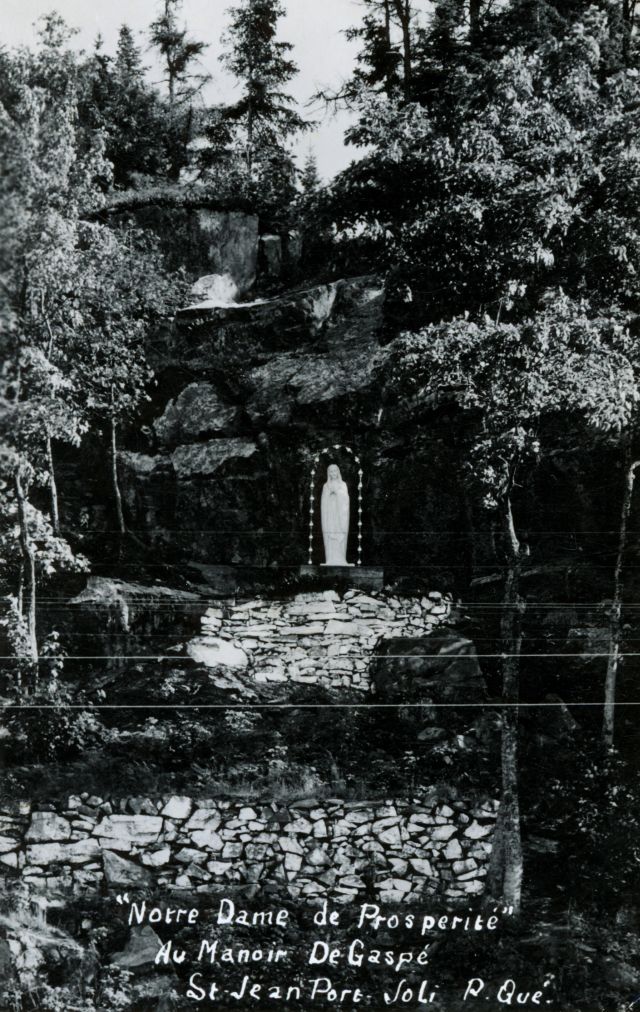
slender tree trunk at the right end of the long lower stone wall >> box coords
[493,497,524,914]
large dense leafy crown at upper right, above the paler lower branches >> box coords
[330,8,640,322]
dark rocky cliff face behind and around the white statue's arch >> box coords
[121,276,460,589]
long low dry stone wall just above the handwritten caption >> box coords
[0,793,498,903]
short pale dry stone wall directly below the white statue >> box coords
[188,590,452,691]
